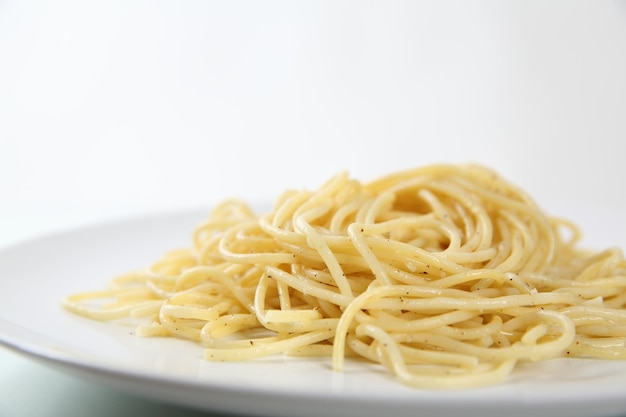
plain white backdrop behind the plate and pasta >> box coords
[0,0,626,415]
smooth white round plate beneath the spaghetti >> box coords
[0,208,626,417]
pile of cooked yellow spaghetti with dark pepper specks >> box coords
[63,165,626,388]
